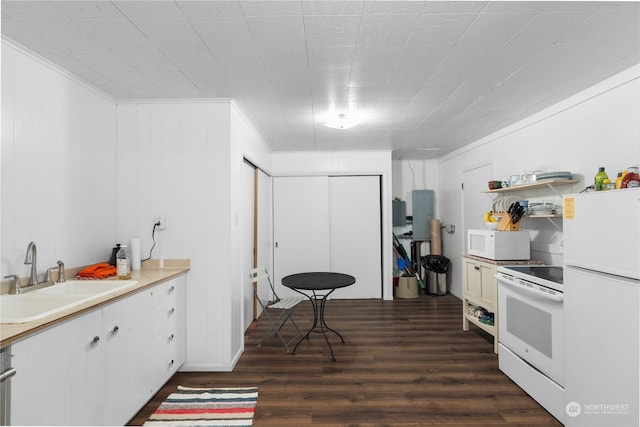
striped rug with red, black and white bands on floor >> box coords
[144,386,258,426]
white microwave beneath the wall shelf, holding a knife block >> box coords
[467,230,531,260]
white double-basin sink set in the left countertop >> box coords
[0,280,137,323]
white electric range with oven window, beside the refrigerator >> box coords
[496,266,566,422]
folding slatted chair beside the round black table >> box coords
[249,267,304,353]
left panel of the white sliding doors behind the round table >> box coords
[273,176,330,297]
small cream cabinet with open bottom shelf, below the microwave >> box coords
[462,256,498,354]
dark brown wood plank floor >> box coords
[131,295,561,427]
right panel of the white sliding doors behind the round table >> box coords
[329,176,382,299]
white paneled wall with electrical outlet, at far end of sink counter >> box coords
[117,100,270,371]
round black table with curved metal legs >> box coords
[282,272,356,362]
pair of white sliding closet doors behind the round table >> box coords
[273,176,382,298]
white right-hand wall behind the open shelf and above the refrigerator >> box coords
[439,67,640,296]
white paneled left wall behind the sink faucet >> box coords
[0,40,117,280]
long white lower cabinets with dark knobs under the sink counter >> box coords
[11,275,186,425]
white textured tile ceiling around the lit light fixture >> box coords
[2,0,640,159]
